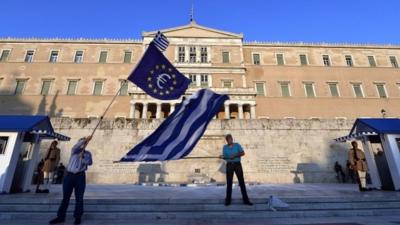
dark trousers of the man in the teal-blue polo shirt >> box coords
[225,162,249,202]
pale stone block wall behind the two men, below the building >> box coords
[42,118,353,184]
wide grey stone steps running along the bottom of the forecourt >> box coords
[0,195,400,220]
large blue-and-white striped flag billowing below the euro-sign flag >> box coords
[121,89,229,161]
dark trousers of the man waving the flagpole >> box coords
[57,172,86,219]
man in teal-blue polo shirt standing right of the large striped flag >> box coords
[220,134,253,206]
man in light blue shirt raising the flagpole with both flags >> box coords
[50,136,93,224]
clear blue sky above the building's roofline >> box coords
[0,0,400,44]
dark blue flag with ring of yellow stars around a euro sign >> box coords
[128,42,190,100]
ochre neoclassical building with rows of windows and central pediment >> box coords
[0,21,400,119]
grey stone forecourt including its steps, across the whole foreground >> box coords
[0,184,400,225]
